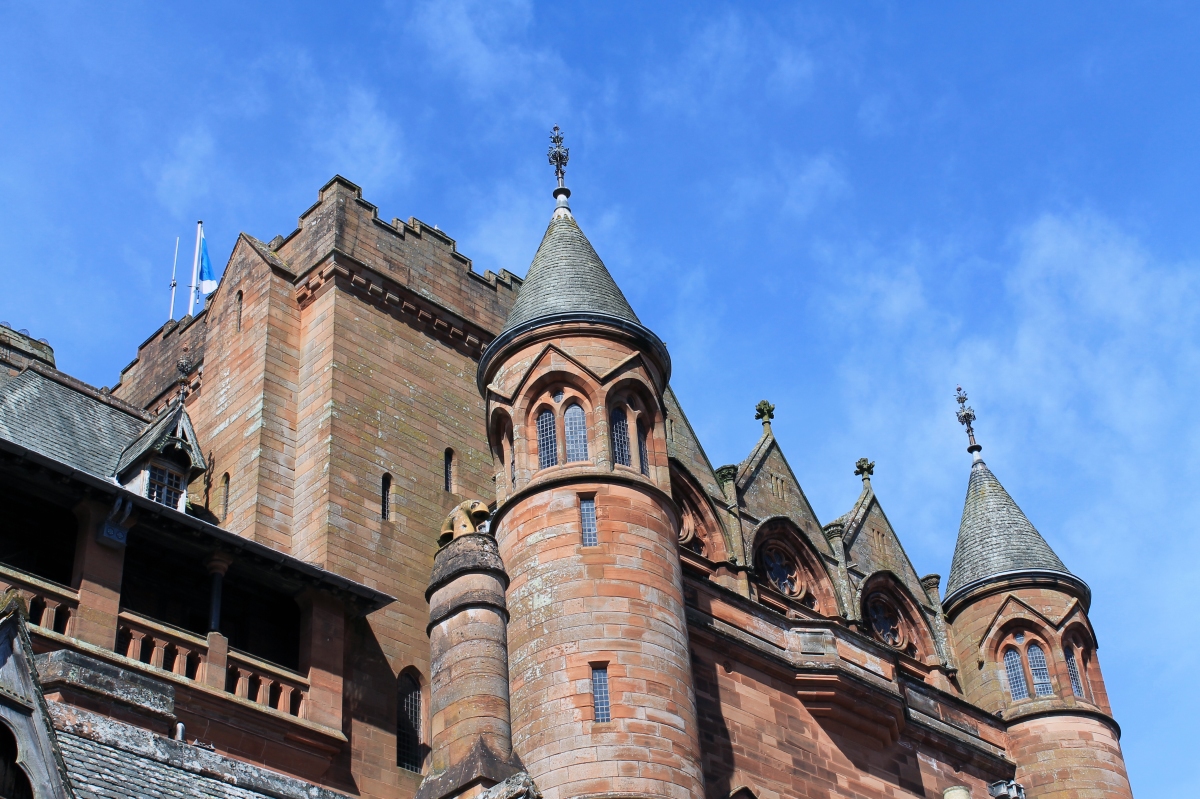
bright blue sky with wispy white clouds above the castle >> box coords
[0,0,1200,795]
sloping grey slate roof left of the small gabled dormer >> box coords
[0,368,146,480]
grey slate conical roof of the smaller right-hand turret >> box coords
[946,461,1070,597]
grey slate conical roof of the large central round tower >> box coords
[502,214,641,334]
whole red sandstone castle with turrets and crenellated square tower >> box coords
[0,136,1132,799]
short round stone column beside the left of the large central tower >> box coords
[416,523,521,799]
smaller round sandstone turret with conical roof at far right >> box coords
[942,389,1133,799]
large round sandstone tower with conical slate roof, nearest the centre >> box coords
[479,143,703,799]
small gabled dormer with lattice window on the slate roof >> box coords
[114,400,208,512]
